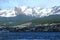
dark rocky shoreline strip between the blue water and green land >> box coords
[0,23,60,32]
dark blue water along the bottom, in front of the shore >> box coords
[0,30,60,40]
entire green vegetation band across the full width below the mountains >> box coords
[0,17,60,26]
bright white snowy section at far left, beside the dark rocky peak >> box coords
[0,10,16,17]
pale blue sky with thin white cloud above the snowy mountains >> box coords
[0,0,60,9]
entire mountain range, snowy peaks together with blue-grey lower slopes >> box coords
[0,6,60,22]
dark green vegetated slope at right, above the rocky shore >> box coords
[32,18,60,25]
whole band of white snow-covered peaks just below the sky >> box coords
[0,6,60,17]
